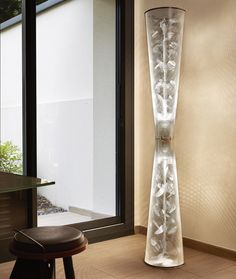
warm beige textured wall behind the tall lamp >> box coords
[135,0,236,250]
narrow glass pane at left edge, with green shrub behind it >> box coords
[0,21,22,173]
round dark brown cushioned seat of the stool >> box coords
[10,226,87,259]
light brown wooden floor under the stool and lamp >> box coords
[0,235,236,279]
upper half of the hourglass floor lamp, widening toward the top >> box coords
[145,8,185,139]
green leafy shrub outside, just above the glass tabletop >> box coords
[0,141,22,174]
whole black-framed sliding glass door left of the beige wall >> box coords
[0,0,134,260]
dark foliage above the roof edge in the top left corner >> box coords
[0,0,47,23]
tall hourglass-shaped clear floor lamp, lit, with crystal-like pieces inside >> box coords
[145,7,185,267]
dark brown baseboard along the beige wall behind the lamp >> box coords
[135,226,236,261]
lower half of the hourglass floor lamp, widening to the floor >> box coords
[145,140,184,267]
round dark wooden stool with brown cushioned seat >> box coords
[10,226,87,279]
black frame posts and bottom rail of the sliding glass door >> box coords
[22,0,134,243]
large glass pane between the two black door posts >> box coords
[37,0,116,226]
